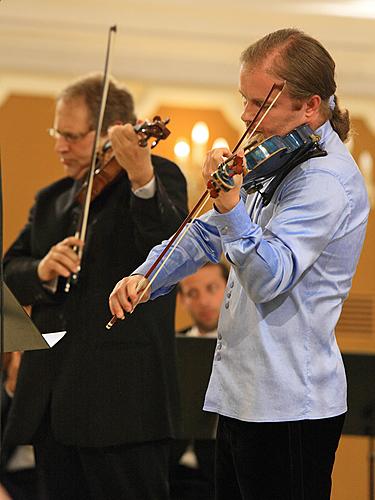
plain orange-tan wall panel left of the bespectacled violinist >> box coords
[0,95,62,248]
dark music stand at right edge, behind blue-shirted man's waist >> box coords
[342,354,375,500]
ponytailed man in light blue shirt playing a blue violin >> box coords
[110,29,369,500]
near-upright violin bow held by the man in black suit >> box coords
[65,25,117,293]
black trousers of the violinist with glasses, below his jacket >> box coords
[34,429,169,500]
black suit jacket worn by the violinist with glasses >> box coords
[4,156,187,447]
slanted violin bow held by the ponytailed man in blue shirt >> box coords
[106,82,286,330]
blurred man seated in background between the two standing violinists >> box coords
[170,262,228,500]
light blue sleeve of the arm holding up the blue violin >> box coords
[208,169,350,303]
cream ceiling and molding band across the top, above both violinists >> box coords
[0,0,375,98]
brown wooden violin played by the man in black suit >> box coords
[76,116,171,206]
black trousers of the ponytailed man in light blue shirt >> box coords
[216,415,345,500]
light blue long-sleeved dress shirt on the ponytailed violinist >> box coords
[135,122,369,422]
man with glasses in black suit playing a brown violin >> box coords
[4,76,186,500]
